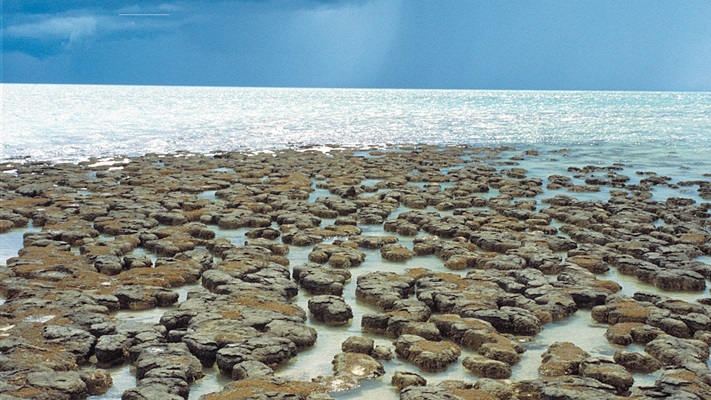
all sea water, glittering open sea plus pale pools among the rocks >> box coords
[0,84,711,399]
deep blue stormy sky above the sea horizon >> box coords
[0,0,711,91]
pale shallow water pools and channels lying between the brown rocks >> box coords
[0,148,711,400]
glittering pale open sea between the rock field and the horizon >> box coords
[0,84,711,171]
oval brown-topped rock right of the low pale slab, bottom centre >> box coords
[395,335,461,371]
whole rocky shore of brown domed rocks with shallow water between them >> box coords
[0,145,711,400]
